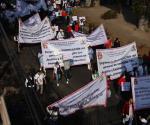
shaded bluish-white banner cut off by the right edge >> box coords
[131,76,150,110]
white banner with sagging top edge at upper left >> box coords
[19,17,54,43]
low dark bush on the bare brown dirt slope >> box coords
[101,10,117,20]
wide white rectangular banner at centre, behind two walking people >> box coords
[41,37,90,68]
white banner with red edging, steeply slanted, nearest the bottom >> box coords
[47,75,107,115]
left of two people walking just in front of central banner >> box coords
[53,62,63,86]
